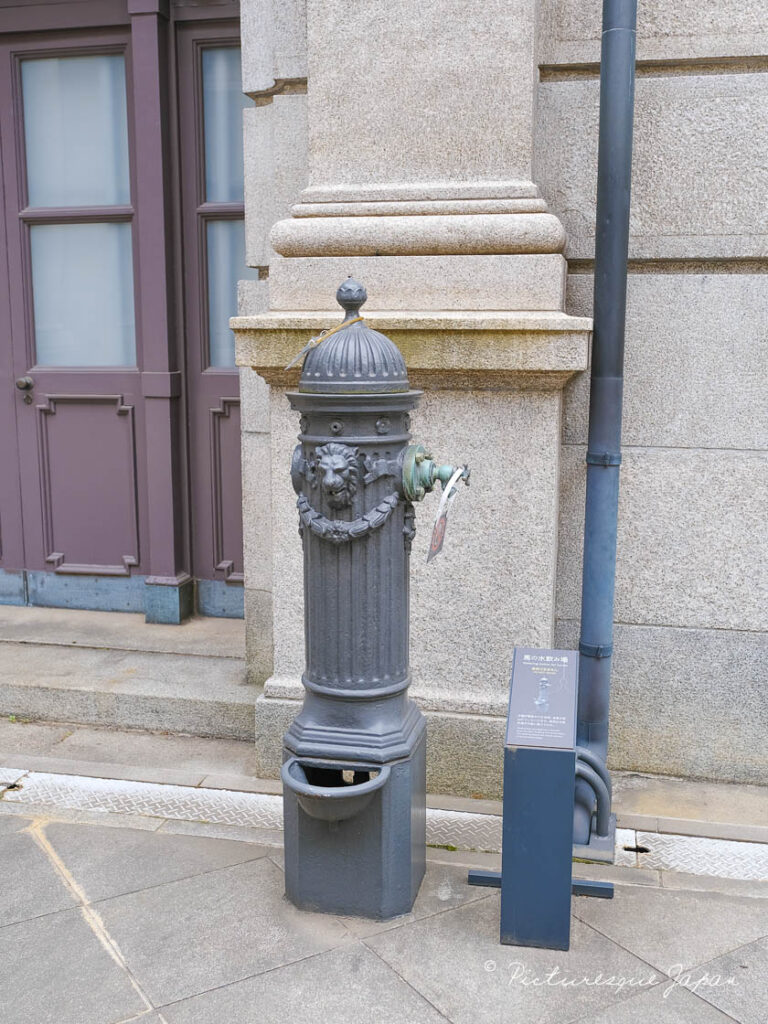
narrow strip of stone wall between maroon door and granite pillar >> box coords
[238,0,307,683]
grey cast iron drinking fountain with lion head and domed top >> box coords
[282,278,469,920]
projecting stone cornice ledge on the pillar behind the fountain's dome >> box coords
[229,311,592,390]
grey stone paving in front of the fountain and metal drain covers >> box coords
[0,809,768,1024]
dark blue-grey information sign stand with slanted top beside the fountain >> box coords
[468,647,613,949]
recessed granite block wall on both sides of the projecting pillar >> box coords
[240,0,768,785]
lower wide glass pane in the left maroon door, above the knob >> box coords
[30,223,136,367]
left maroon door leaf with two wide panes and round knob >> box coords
[0,31,153,608]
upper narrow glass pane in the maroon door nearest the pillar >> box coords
[203,46,252,203]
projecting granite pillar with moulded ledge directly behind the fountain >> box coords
[232,0,590,797]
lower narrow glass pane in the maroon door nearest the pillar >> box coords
[206,220,259,368]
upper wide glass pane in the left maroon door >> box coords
[22,53,130,207]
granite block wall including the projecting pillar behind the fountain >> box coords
[236,0,768,796]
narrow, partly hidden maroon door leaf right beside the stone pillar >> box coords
[177,22,257,614]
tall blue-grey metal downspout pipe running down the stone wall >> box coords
[573,0,637,844]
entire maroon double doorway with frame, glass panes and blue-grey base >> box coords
[0,0,251,622]
